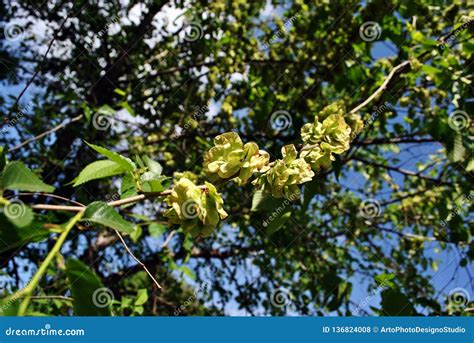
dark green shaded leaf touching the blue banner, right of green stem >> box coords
[66,259,113,316]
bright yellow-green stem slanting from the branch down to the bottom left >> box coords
[16,211,84,316]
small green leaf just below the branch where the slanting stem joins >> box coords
[82,201,135,234]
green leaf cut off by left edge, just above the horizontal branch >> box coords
[1,161,54,193]
